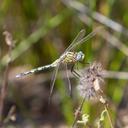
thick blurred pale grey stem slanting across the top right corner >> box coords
[61,0,128,36]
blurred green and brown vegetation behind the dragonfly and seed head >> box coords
[0,0,128,128]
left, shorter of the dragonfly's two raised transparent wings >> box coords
[65,29,85,52]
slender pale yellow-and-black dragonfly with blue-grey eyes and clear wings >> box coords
[16,27,101,101]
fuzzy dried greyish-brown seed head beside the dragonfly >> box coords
[77,62,103,99]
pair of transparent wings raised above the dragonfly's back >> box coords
[66,27,103,52]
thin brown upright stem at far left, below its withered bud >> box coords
[0,45,12,124]
